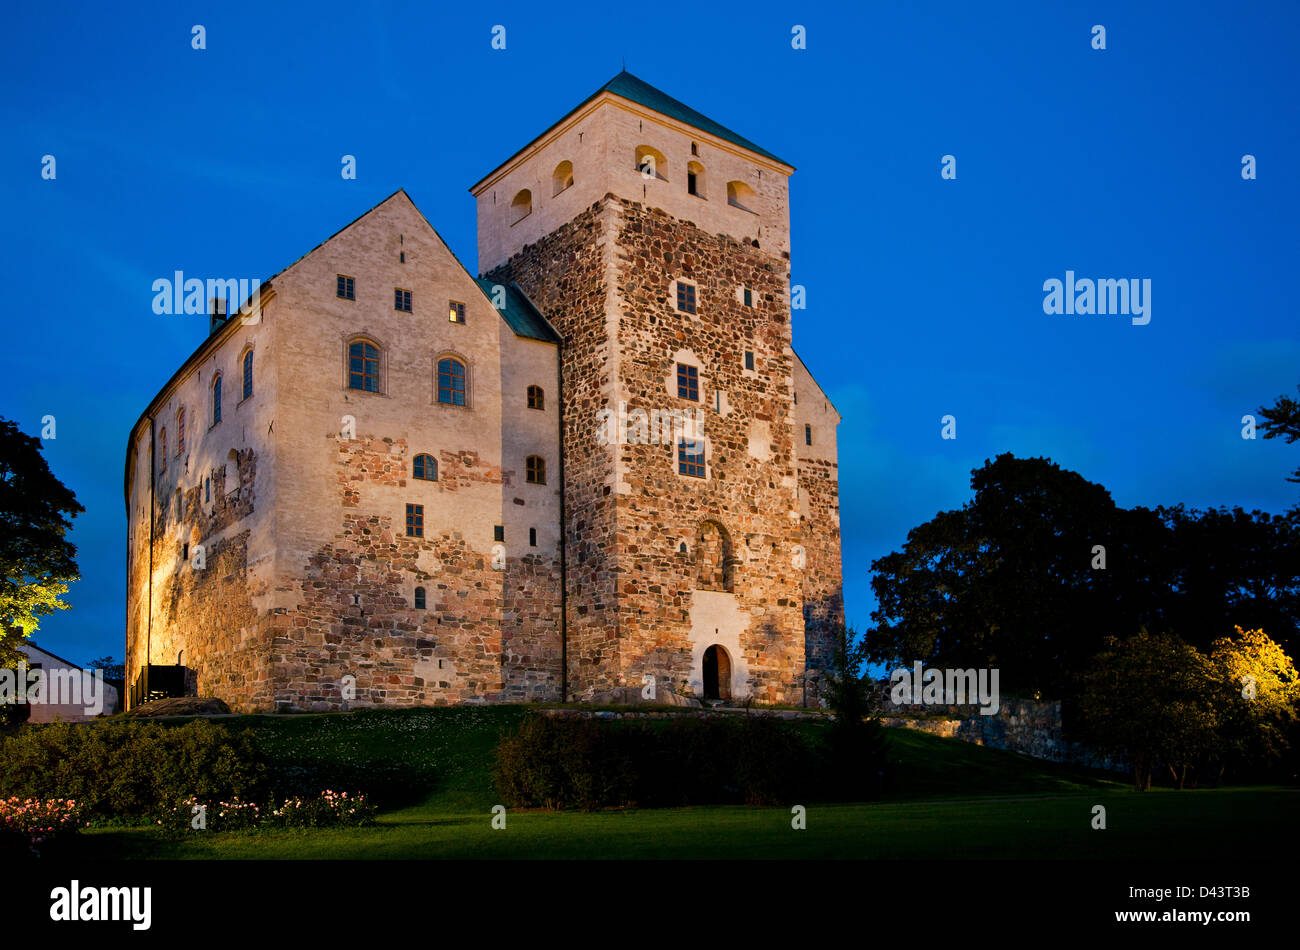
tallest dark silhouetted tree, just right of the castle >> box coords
[867,454,1167,695]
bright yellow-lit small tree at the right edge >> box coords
[1210,626,1300,776]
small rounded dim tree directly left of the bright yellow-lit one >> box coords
[1079,630,1222,791]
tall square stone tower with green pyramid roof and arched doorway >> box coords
[471,71,842,702]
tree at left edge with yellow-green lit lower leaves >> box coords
[0,418,85,665]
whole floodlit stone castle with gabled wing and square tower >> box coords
[125,71,842,711]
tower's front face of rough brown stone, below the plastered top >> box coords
[605,200,803,702]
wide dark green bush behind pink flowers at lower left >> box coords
[0,720,267,824]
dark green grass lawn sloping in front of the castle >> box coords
[68,706,1300,860]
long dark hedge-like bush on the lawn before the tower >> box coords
[495,715,820,810]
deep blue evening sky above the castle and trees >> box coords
[0,0,1300,660]
